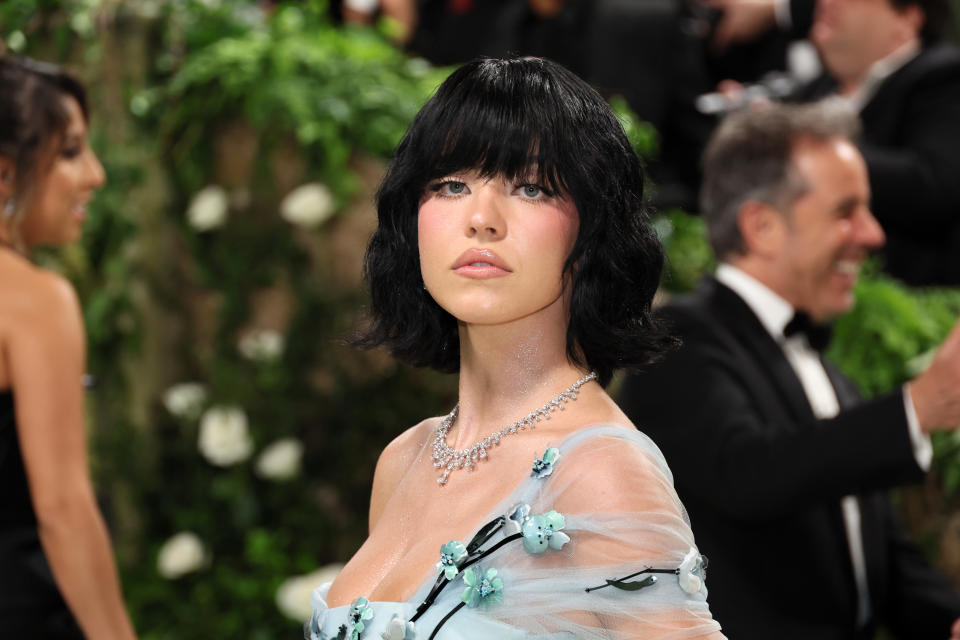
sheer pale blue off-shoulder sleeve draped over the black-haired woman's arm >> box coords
[481,426,723,640]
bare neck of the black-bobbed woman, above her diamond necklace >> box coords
[449,320,586,448]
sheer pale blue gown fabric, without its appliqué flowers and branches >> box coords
[305,425,723,640]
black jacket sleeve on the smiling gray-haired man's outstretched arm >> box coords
[619,313,922,520]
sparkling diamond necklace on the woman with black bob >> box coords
[431,371,597,487]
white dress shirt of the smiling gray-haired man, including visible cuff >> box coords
[716,264,933,626]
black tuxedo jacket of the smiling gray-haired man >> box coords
[618,278,960,640]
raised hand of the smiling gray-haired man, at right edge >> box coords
[909,322,960,436]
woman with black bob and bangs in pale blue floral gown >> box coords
[306,58,723,640]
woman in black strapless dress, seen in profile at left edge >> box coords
[0,53,134,640]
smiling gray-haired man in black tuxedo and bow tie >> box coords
[619,104,960,640]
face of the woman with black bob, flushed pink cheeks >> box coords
[417,171,579,325]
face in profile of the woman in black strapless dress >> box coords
[20,97,105,248]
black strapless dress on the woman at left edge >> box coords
[0,391,84,640]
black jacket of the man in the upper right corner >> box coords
[794,44,960,285]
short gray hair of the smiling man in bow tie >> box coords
[700,99,859,260]
